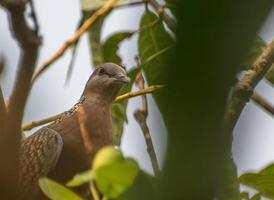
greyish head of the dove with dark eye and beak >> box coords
[84,63,130,101]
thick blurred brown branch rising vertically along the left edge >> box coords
[0,0,40,199]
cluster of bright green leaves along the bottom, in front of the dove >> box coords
[39,146,139,200]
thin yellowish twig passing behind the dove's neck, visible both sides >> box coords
[21,85,163,131]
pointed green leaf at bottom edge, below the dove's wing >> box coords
[39,178,82,200]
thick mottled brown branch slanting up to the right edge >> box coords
[224,40,274,137]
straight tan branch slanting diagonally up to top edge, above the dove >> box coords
[32,0,118,83]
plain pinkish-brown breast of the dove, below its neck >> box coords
[48,101,113,182]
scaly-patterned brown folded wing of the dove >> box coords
[19,127,63,199]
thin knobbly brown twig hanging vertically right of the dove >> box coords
[134,72,160,176]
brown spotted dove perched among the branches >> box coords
[19,63,130,200]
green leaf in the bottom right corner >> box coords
[239,164,274,199]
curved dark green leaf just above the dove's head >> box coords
[103,32,134,64]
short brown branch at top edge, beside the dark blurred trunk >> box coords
[147,0,177,33]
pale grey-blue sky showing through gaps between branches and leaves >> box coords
[0,0,274,186]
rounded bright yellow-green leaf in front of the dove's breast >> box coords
[93,146,139,198]
